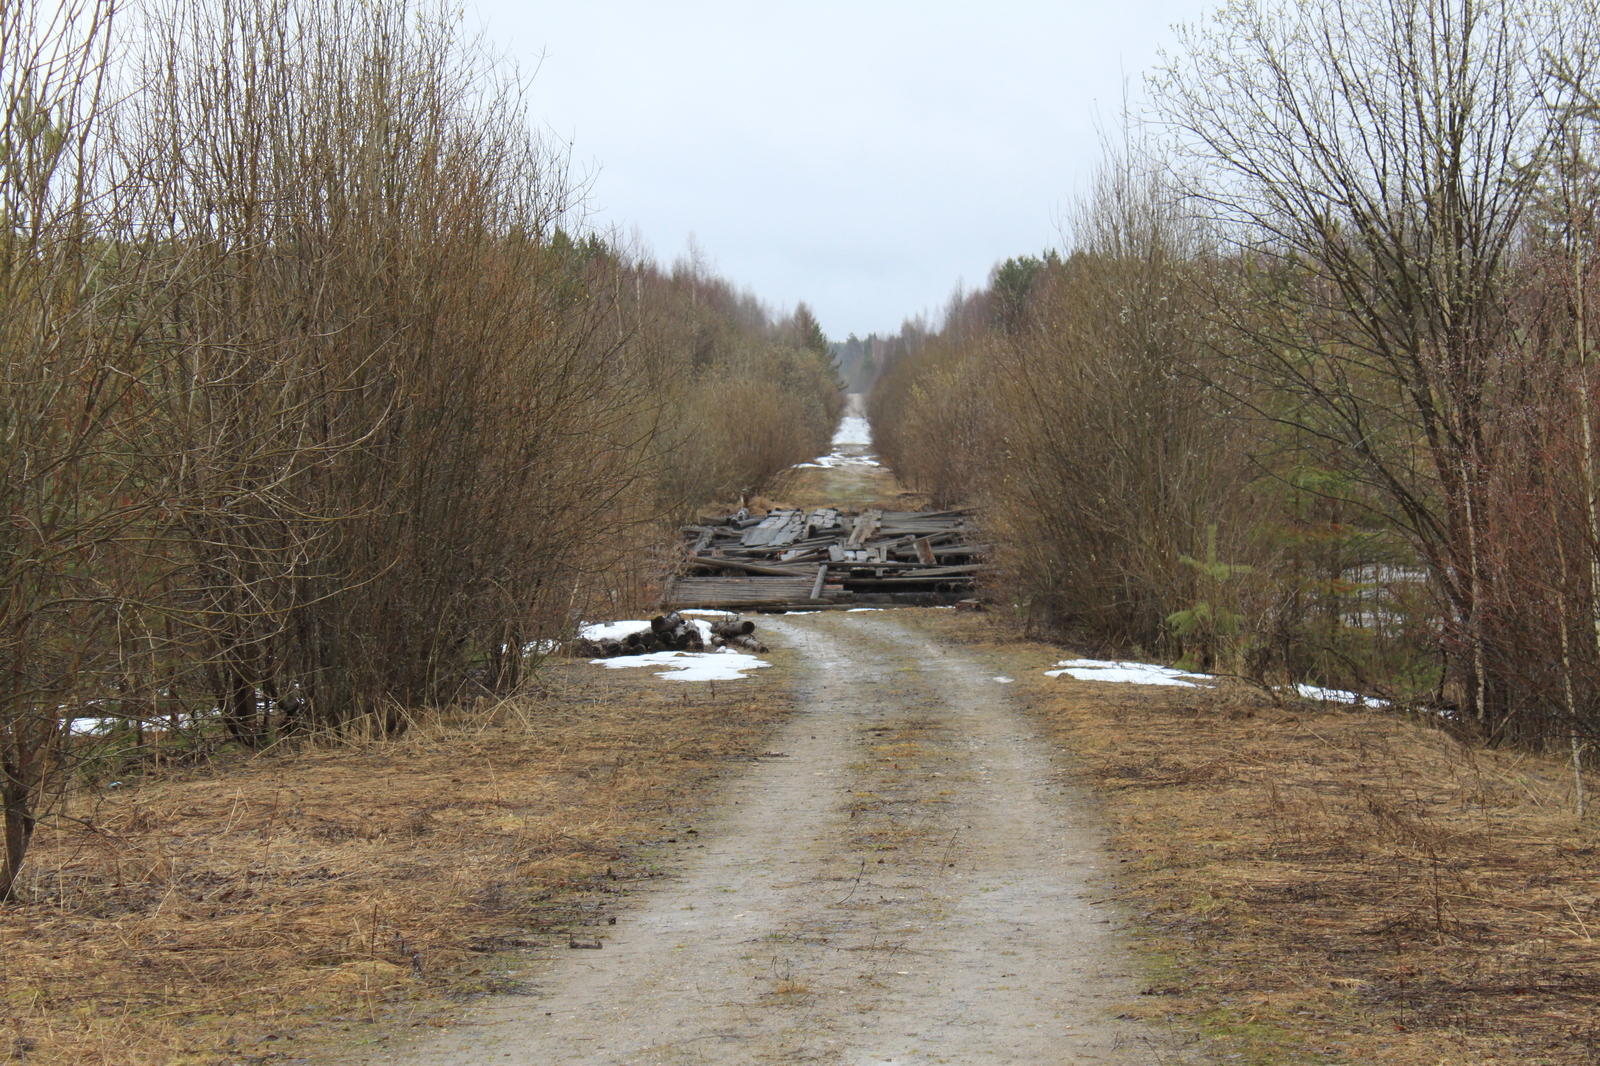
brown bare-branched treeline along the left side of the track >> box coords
[0,0,840,898]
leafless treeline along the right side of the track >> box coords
[870,0,1600,755]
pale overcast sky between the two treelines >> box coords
[466,0,1213,339]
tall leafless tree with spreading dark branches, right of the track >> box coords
[1155,0,1573,730]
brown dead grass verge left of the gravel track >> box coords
[0,653,790,1066]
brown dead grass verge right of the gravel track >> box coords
[918,611,1600,1066]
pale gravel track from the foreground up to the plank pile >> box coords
[373,611,1187,1066]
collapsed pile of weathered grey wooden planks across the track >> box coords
[662,507,986,608]
